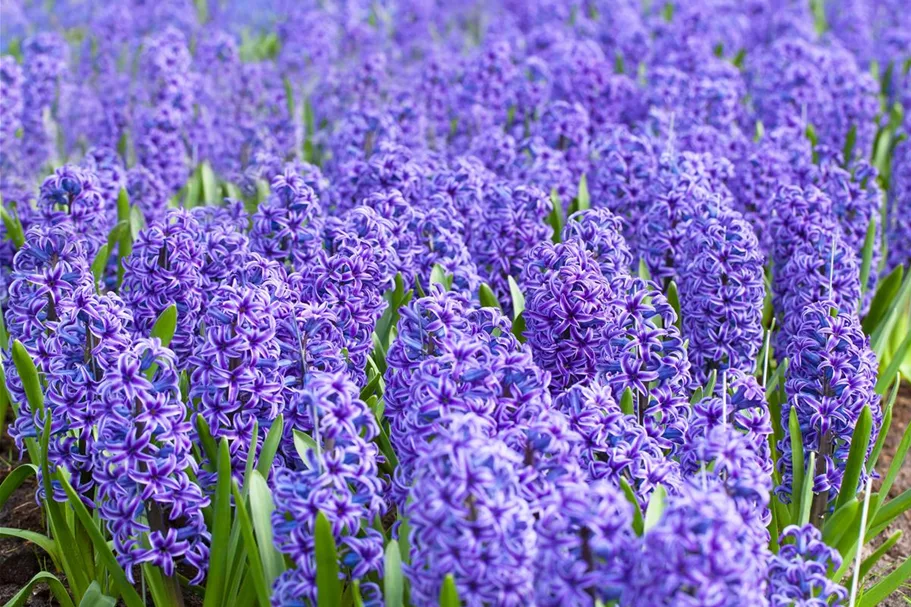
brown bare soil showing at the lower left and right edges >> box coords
[0,384,911,607]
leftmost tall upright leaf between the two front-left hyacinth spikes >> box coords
[200,440,233,607]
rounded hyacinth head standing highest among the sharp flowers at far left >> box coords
[37,164,110,260]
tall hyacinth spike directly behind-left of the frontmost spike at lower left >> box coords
[42,287,132,504]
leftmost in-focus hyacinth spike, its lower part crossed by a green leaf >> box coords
[3,226,93,450]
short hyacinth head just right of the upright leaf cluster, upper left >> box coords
[250,170,323,270]
